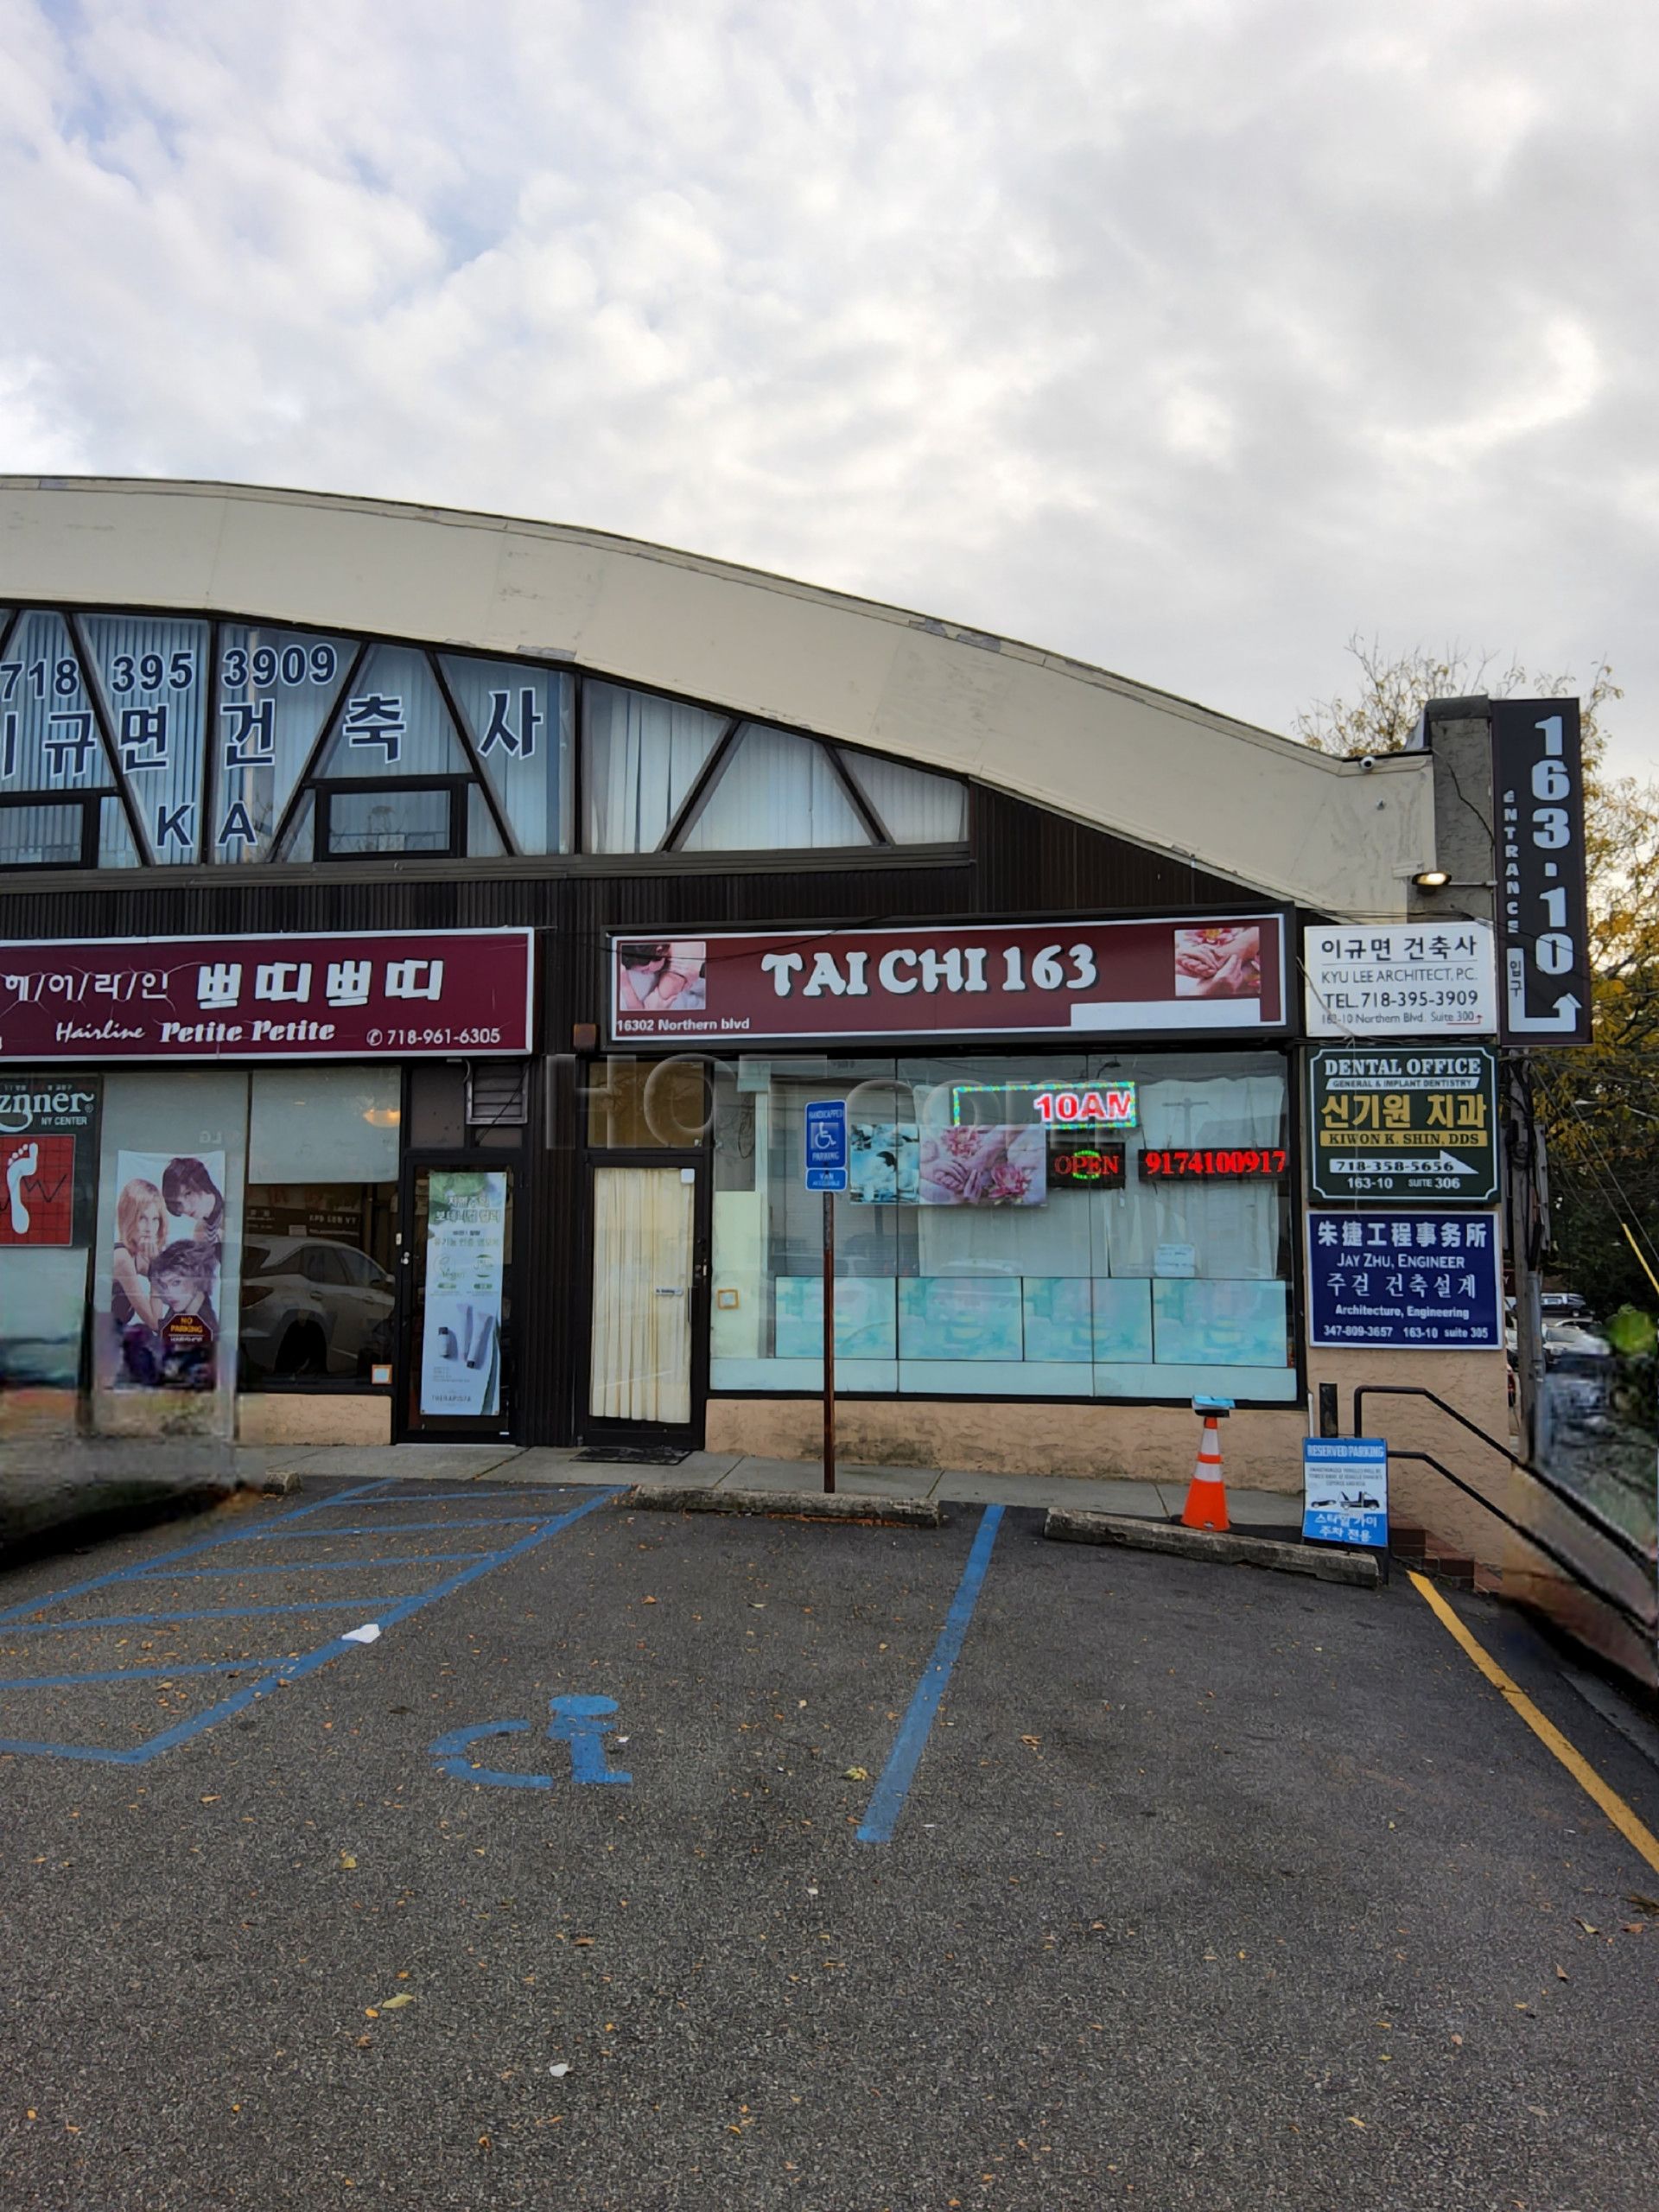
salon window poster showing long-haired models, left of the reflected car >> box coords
[104,1153,226,1389]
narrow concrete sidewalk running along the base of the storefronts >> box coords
[0,1438,1300,1529]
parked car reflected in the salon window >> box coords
[241,1236,396,1380]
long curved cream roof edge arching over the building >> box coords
[0,475,1433,918]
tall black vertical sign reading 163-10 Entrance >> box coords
[1491,699,1591,1044]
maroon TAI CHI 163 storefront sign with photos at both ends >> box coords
[611,913,1287,1044]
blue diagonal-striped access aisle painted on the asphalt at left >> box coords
[0,1484,624,1767]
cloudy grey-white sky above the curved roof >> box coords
[0,0,1659,772]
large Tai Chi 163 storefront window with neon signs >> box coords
[710,1053,1296,1402]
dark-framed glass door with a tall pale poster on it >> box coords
[400,1153,513,1442]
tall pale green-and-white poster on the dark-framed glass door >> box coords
[420,1168,506,1421]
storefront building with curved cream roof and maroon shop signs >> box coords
[0,480,1504,1486]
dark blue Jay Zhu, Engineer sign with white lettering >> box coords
[1307,1212,1504,1351]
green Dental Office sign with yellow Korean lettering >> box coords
[1307,1044,1497,1205]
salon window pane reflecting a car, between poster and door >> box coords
[238,1068,398,1389]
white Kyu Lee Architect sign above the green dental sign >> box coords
[1303,920,1497,1038]
